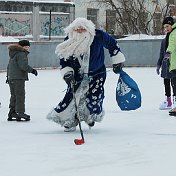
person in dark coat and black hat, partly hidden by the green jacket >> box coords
[156,17,175,110]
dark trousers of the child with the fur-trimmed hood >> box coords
[9,80,25,112]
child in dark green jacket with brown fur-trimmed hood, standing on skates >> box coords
[6,40,38,121]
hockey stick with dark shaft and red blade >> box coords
[72,82,85,145]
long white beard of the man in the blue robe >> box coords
[55,31,94,60]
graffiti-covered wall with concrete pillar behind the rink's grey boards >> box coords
[0,1,75,40]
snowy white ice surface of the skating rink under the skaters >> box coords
[0,68,176,176]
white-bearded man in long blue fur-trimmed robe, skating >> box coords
[47,18,125,131]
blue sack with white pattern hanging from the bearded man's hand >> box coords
[116,70,141,111]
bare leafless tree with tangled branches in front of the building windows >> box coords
[84,0,174,35]
